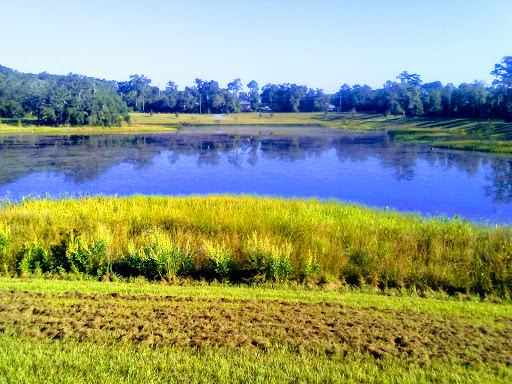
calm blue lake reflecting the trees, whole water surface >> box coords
[0,127,512,223]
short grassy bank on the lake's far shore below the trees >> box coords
[0,113,512,153]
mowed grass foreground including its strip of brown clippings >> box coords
[0,277,512,383]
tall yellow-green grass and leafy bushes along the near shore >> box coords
[0,196,512,296]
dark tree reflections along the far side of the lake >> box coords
[0,131,512,216]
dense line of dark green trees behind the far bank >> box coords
[0,56,512,126]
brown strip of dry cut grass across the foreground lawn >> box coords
[0,291,512,364]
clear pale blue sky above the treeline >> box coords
[0,0,512,92]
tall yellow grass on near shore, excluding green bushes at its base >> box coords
[0,195,512,294]
